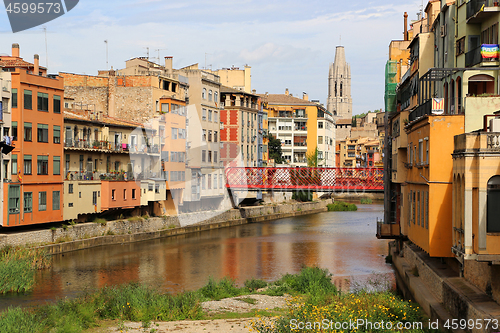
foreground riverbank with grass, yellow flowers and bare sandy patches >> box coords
[0,267,438,333]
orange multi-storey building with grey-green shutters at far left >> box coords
[0,44,64,227]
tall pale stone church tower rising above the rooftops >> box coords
[327,46,352,120]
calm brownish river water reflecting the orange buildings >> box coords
[0,204,394,309]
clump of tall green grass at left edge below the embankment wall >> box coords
[0,247,51,294]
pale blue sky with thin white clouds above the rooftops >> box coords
[0,0,422,114]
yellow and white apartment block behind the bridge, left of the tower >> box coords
[261,89,335,167]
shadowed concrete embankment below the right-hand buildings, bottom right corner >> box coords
[389,243,500,333]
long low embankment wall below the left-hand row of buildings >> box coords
[0,199,333,254]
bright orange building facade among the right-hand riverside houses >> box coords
[401,111,464,257]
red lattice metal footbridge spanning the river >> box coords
[226,167,384,192]
